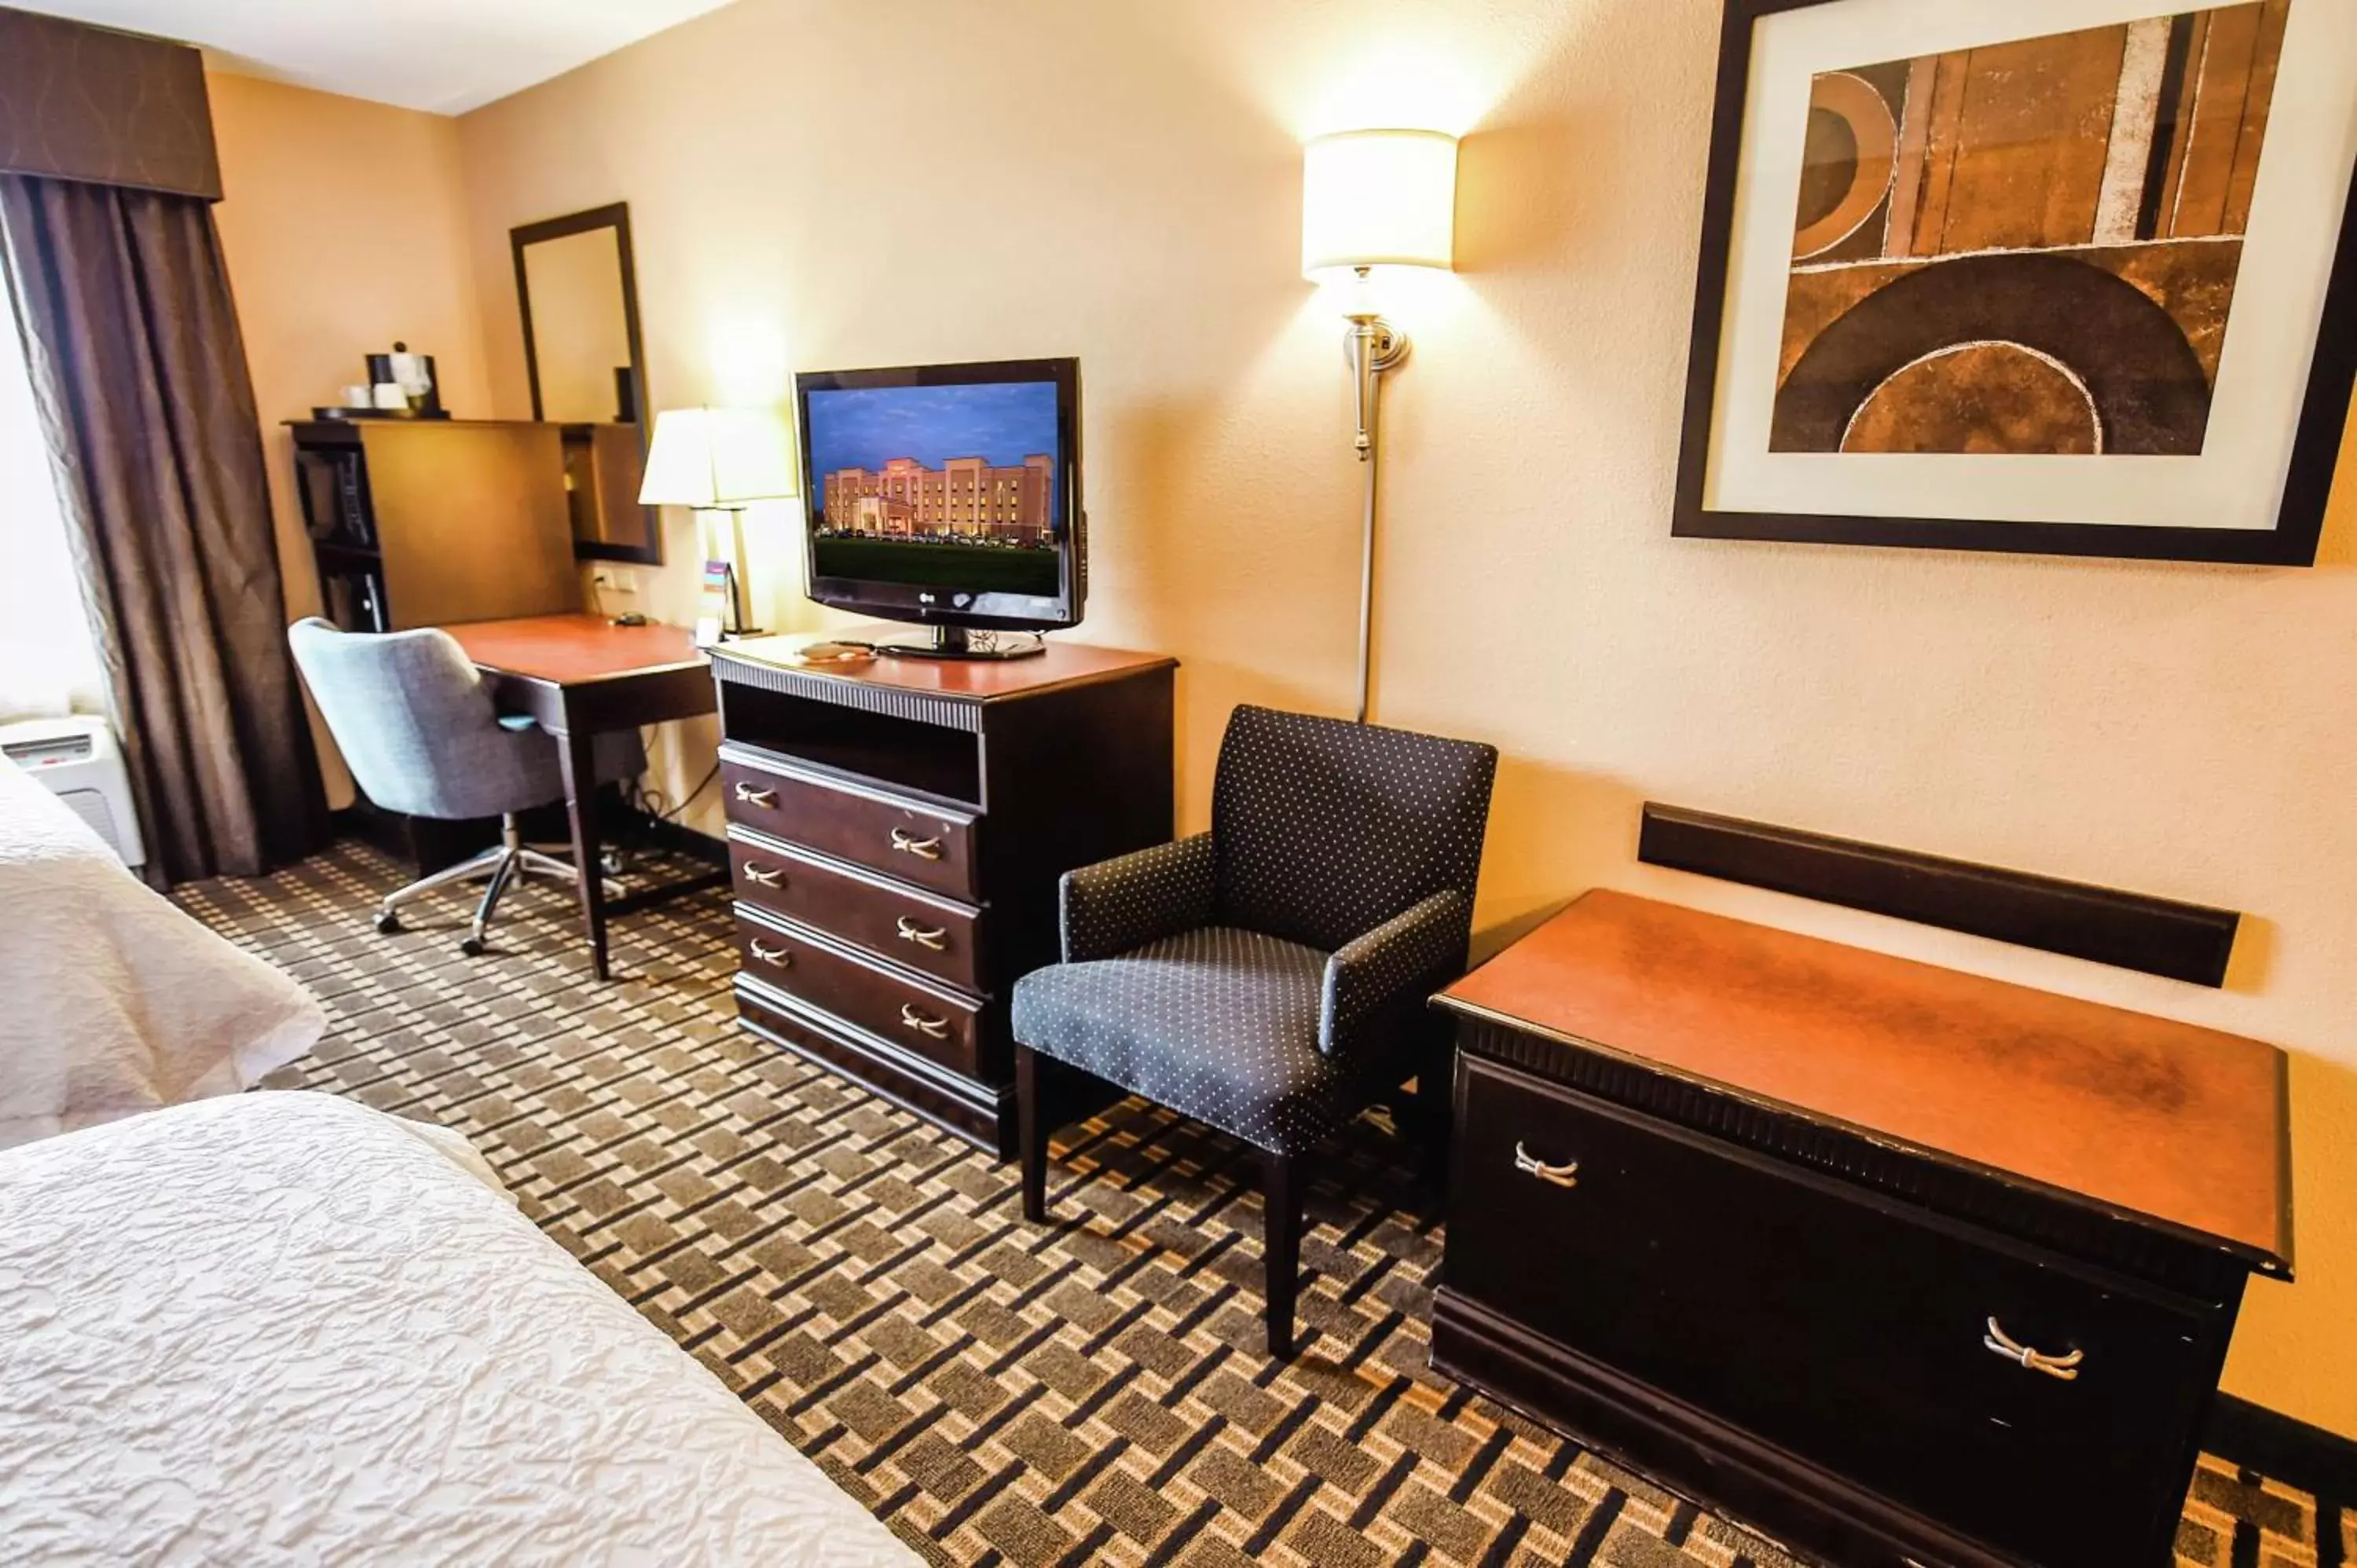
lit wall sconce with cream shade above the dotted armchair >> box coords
[1301,130,1457,724]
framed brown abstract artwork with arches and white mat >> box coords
[1673,0,2357,566]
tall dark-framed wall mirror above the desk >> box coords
[509,203,662,566]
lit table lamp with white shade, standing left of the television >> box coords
[639,408,794,646]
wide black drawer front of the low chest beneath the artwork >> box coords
[1445,1057,2218,1566]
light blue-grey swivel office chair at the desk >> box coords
[288,615,646,955]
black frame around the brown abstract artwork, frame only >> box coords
[1671,0,2357,566]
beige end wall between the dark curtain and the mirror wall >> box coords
[205,73,497,807]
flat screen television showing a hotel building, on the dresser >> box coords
[794,358,1089,655]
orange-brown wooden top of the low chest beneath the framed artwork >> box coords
[1442,889,2291,1266]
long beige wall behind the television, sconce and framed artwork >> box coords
[387,0,2357,1434]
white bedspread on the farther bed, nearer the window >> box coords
[0,761,328,1149]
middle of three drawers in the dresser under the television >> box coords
[728,828,983,991]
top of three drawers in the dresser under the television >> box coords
[721,754,976,901]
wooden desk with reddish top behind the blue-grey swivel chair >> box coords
[443,615,721,981]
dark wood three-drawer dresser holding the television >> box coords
[712,636,1176,1158]
